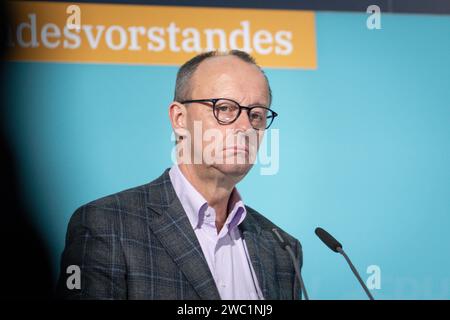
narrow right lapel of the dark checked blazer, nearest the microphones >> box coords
[239,212,279,300]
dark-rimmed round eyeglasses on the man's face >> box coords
[180,98,278,130]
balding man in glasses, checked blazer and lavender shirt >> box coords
[58,50,302,299]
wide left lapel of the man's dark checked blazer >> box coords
[147,170,220,300]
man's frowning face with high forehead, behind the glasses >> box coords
[182,56,269,180]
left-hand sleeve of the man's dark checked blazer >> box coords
[56,204,127,299]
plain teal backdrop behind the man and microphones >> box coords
[6,12,450,299]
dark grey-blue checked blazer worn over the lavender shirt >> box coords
[57,169,302,300]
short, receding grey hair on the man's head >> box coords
[174,50,272,106]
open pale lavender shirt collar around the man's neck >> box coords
[169,164,247,230]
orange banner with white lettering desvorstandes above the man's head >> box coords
[6,2,317,69]
